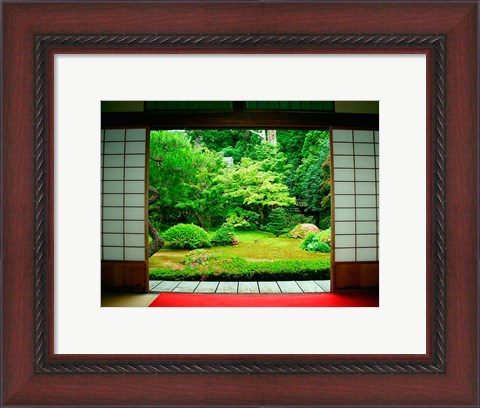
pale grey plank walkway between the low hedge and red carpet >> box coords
[150,280,330,293]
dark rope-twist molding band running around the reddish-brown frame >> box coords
[34,34,446,374]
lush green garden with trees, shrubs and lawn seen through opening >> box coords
[148,129,331,280]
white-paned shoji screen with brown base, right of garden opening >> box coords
[331,129,379,289]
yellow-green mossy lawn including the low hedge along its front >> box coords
[150,231,330,280]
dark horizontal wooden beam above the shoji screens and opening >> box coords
[102,111,379,130]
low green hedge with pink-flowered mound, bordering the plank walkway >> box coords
[150,250,330,281]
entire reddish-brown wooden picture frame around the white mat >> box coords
[1,1,478,406]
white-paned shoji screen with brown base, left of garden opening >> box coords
[101,129,148,291]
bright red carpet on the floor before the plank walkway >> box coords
[149,292,378,307]
